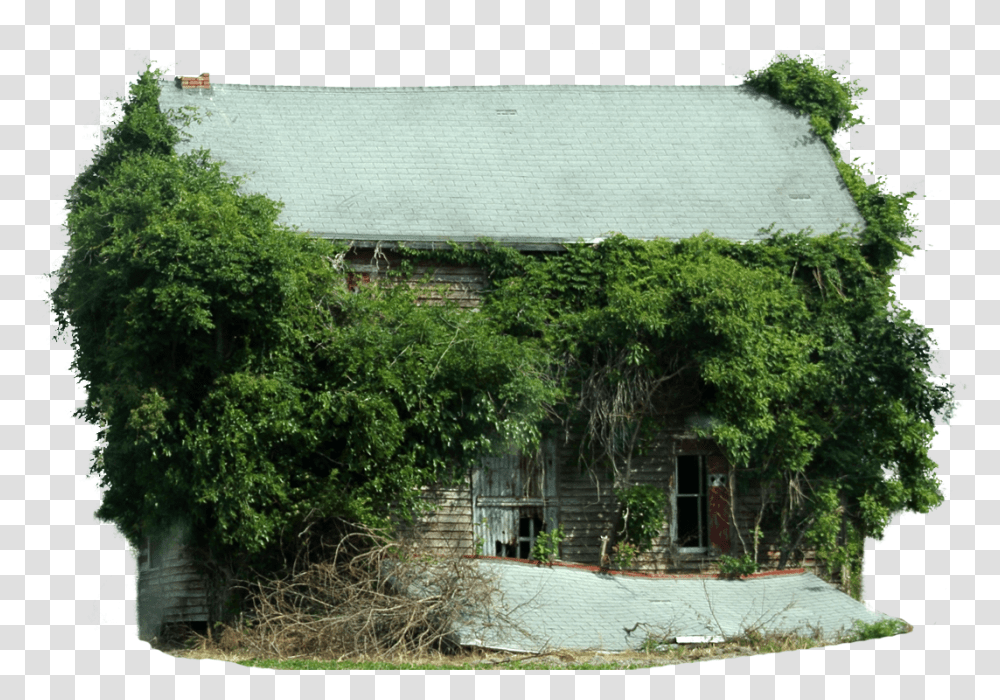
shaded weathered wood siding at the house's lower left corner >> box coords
[136,527,208,640]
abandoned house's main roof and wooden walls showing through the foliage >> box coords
[138,74,864,635]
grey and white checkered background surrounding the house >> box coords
[0,0,1000,699]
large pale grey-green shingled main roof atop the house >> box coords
[160,75,864,248]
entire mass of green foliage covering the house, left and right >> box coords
[52,54,953,612]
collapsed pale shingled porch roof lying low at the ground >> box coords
[426,560,889,652]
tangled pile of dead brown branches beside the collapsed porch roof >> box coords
[209,527,508,661]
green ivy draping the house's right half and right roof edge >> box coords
[396,55,954,595]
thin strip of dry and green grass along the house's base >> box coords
[160,619,913,671]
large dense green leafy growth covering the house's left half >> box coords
[52,65,555,592]
